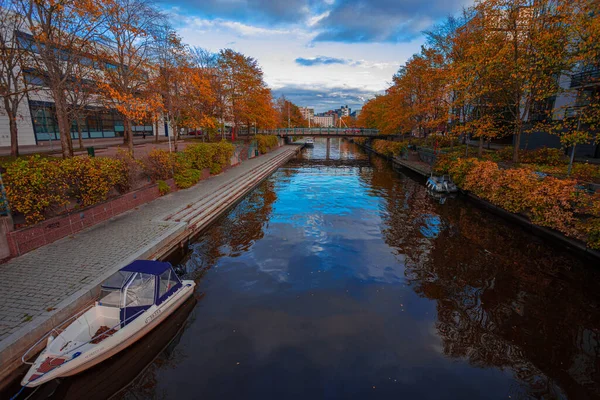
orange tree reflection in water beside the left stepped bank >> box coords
[187,179,277,271]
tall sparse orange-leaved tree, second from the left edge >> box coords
[15,0,105,157]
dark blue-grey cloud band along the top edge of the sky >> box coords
[162,0,473,43]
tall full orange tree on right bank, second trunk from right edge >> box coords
[468,0,569,162]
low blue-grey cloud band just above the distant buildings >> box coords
[273,84,378,112]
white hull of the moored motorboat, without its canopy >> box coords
[21,281,195,387]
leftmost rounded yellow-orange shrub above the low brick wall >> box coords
[4,156,68,224]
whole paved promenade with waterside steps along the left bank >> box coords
[0,145,300,381]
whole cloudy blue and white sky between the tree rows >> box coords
[160,0,472,112]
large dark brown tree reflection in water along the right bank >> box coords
[363,156,600,399]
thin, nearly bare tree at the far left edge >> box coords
[0,0,27,157]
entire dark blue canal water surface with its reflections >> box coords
[5,140,600,399]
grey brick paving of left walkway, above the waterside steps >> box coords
[0,146,298,361]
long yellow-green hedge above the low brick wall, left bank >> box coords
[4,142,235,224]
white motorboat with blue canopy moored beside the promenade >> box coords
[21,260,196,387]
